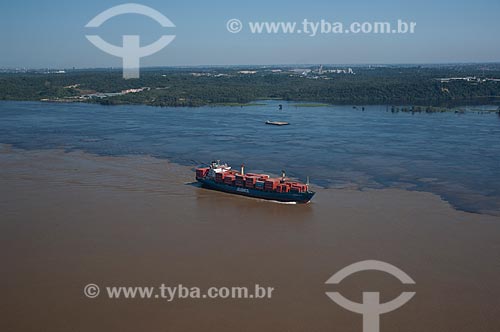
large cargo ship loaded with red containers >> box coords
[196,161,314,203]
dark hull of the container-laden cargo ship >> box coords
[196,178,314,203]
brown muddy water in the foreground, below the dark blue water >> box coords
[0,145,500,332]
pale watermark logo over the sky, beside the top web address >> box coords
[85,3,175,79]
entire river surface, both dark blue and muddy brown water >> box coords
[0,101,500,332]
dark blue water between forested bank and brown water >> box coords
[0,101,500,214]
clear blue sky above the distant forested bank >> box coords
[0,0,500,68]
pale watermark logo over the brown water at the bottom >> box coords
[326,260,415,332]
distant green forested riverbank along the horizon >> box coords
[0,64,500,108]
